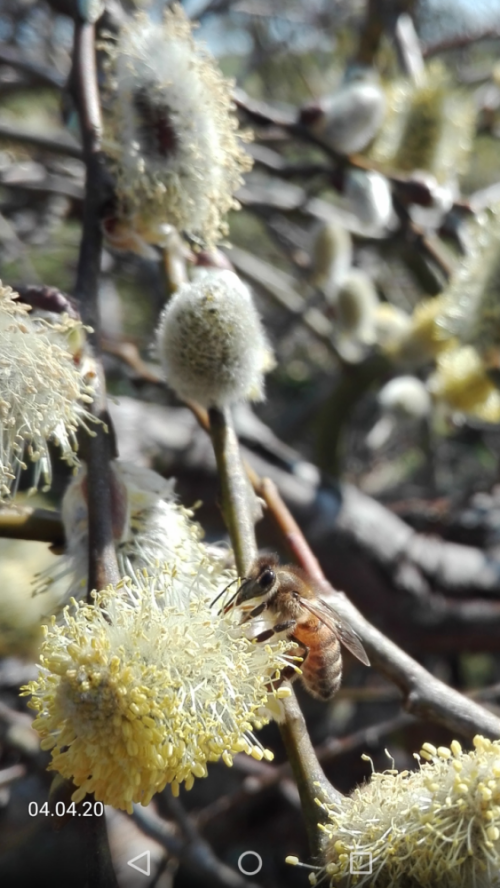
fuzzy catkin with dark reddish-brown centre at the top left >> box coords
[103,4,251,245]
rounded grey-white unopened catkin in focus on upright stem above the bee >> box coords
[157,271,273,407]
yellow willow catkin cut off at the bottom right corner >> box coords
[289,736,500,888]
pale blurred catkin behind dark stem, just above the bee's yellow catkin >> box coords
[35,460,225,603]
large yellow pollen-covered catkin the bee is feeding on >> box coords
[23,569,290,812]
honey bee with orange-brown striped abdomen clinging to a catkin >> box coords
[223,555,370,700]
